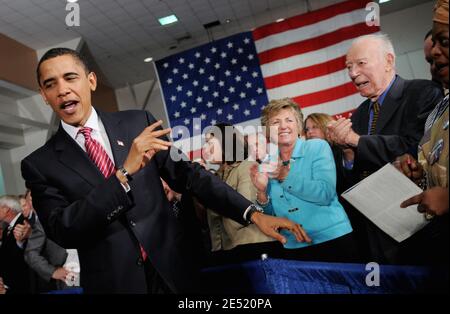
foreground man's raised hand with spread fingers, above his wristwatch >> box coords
[123,120,172,175]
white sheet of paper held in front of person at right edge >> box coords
[342,164,428,242]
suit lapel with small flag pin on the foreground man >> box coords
[97,110,131,168]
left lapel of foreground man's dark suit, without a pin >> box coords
[55,125,104,186]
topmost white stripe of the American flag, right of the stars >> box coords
[255,9,367,53]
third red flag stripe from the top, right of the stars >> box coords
[264,56,345,89]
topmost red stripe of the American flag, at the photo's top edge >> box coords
[253,0,369,41]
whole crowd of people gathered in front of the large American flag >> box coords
[0,0,449,294]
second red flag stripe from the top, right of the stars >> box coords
[258,23,380,65]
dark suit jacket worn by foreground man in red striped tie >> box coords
[22,111,250,293]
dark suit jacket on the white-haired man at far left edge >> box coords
[0,215,32,294]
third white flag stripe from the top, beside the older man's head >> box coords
[267,69,351,99]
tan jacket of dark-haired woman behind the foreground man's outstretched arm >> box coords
[208,160,274,251]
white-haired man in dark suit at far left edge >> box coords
[0,195,32,294]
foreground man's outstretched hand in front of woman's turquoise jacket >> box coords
[251,212,312,244]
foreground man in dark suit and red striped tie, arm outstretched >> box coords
[22,48,310,293]
